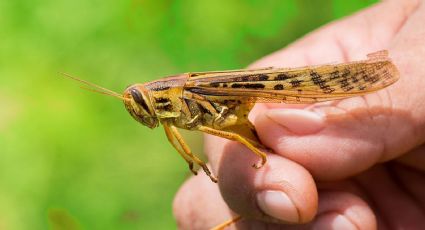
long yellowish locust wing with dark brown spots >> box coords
[184,51,399,103]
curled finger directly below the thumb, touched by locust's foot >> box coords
[214,142,317,224]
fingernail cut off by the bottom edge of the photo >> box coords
[313,213,358,230]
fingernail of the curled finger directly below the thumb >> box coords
[257,191,299,223]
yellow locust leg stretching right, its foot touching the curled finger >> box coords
[198,126,267,169]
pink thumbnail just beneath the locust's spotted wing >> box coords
[266,109,325,135]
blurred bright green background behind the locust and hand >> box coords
[0,0,375,229]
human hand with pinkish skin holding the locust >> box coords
[174,0,425,229]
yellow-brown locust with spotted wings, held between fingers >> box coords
[66,50,399,182]
